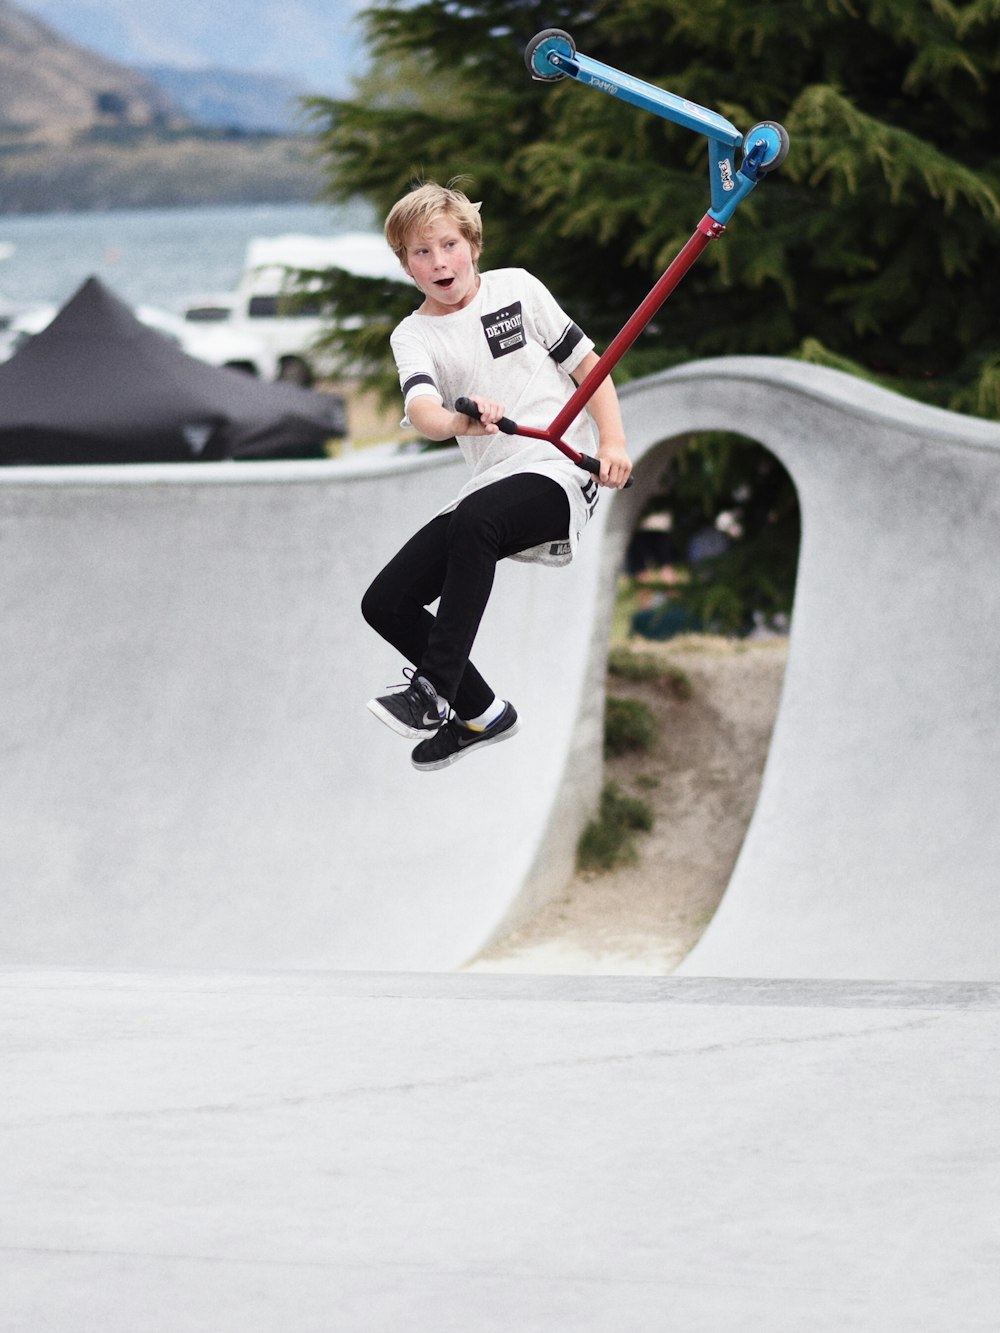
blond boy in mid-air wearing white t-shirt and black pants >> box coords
[361,183,632,770]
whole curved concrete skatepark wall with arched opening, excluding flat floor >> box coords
[0,357,1000,980]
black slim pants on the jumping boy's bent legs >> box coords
[361,472,569,718]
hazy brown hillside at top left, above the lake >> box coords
[0,0,320,213]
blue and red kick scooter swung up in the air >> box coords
[455,28,788,485]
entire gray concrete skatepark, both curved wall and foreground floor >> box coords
[0,359,1000,1333]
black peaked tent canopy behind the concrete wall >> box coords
[0,277,345,464]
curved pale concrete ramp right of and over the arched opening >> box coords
[627,357,1000,980]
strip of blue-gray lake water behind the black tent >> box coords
[0,201,379,309]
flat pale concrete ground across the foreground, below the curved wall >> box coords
[0,969,1000,1333]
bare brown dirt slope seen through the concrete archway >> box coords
[469,636,787,973]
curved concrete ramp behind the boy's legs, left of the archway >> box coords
[0,455,600,969]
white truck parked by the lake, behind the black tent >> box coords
[184,232,409,385]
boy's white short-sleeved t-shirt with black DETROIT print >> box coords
[392,268,599,565]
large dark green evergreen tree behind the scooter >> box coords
[308,0,1000,412]
